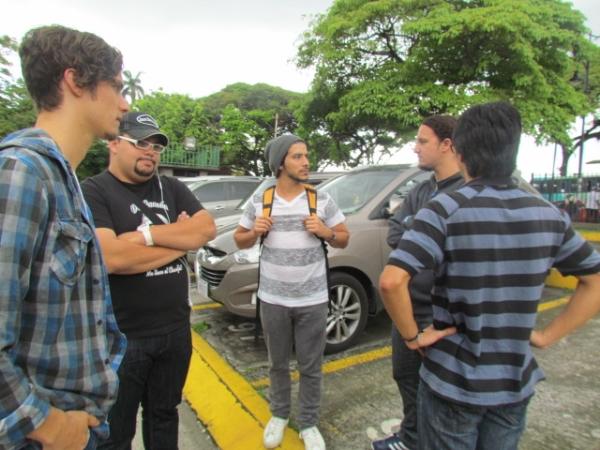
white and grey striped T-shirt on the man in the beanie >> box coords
[240,191,346,307]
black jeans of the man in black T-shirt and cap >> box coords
[98,326,192,450]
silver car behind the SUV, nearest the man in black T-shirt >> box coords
[181,175,261,217]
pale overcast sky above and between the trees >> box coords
[0,0,600,175]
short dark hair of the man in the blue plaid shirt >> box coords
[19,25,123,111]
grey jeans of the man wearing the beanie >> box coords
[260,302,327,430]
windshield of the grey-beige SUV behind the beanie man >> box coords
[317,170,398,214]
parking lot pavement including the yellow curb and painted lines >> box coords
[166,289,600,450]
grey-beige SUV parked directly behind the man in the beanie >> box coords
[195,165,431,353]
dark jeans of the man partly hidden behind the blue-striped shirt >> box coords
[392,324,422,450]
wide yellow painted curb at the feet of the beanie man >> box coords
[183,332,304,450]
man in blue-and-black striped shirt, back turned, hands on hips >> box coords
[380,102,600,450]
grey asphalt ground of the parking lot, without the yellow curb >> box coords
[134,284,600,450]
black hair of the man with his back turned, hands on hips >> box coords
[452,102,521,178]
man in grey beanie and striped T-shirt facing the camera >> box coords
[234,134,349,450]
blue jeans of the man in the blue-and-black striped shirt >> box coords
[417,383,529,450]
